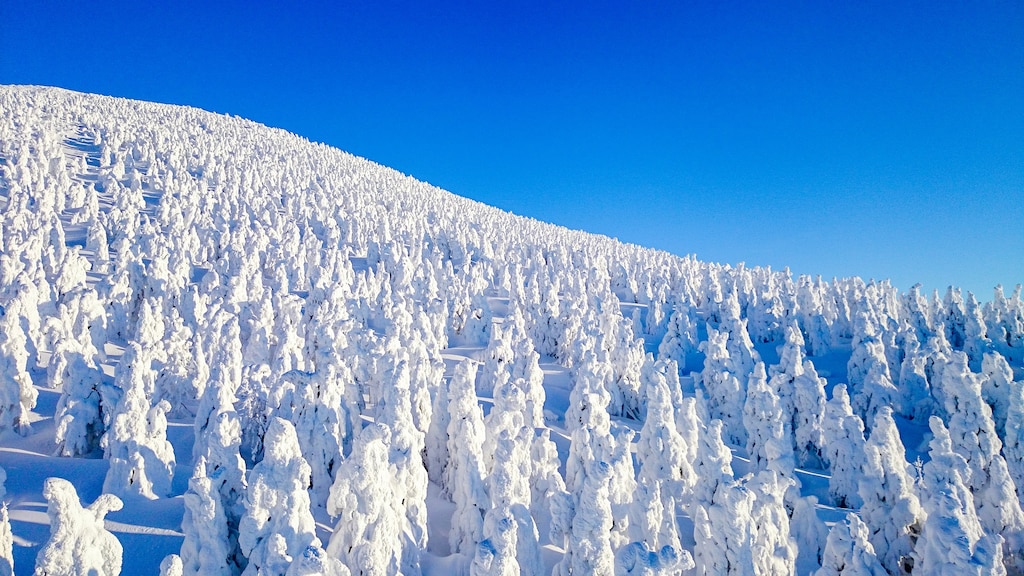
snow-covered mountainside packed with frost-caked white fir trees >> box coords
[0,86,1024,576]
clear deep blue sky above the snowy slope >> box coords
[0,0,1024,300]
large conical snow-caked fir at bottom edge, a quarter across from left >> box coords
[239,418,319,575]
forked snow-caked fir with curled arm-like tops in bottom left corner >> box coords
[35,478,123,576]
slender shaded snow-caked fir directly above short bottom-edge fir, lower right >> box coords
[822,384,864,508]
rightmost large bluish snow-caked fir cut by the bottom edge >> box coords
[913,416,1006,576]
